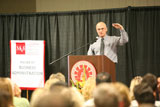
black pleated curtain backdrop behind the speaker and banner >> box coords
[0,7,160,85]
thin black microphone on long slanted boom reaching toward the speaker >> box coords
[49,37,98,65]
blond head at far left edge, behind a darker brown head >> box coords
[0,77,13,105]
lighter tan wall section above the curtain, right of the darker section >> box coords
[36,0,160,12]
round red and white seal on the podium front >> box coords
[71,60,96,83]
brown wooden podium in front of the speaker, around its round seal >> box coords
[68,55,116,84]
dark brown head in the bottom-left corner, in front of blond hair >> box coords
[0,90,13,107]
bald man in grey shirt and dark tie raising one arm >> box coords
[87,22,128,63]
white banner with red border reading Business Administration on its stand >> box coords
[10,40,45,95]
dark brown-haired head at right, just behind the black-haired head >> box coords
[142,73,157,91]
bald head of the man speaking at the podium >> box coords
[96,22,107,37]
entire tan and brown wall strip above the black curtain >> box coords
[0,0,160,13]
